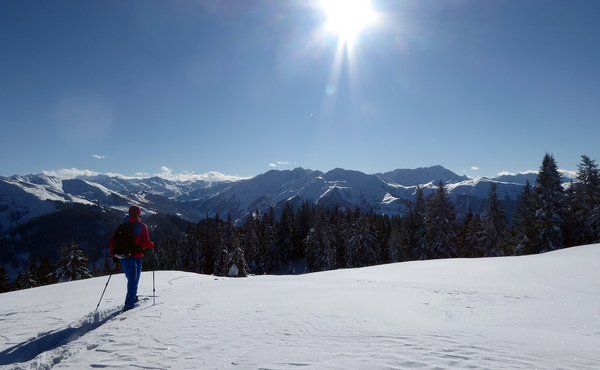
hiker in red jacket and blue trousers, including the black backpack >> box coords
[109,206,154,312]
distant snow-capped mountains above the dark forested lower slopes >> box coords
[0,166,548,233]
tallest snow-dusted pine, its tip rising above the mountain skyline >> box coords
[535,154,565,252]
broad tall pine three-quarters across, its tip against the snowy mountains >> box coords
[427,181,457,258]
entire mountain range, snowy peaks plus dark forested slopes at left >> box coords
[0,166,569,277]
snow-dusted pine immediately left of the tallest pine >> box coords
[513,181,537,255]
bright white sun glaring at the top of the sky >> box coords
[320,0,376,44]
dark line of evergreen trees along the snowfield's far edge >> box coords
[0,154,600,291]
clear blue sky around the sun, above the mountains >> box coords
[0,0,600,177]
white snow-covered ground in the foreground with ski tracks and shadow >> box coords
[0,245,600,369]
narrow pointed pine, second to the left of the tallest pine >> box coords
[482,182,508,257]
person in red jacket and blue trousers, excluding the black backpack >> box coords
[109,206,154,311]
